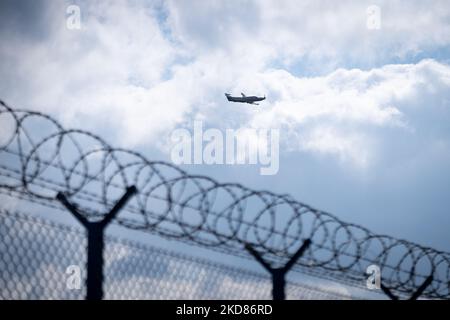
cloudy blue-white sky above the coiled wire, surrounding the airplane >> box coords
[0,0,450,255]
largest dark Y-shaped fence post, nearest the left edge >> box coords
[56,186,137,300]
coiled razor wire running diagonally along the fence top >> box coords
[0,101,450,299]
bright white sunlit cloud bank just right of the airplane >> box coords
[249,60,450,168]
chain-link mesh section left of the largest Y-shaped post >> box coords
[0,210,86,299]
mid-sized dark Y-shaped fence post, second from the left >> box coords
[245,239,311,300]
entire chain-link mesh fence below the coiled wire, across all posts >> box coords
[0,210,350,299]
